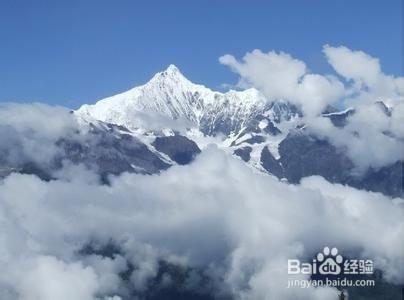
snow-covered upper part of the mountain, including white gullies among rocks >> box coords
[75,65,299,177]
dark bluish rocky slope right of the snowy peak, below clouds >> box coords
[276,131,404,197]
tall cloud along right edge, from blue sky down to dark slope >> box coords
[320,45,404,171]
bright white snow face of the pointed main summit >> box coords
[77,65,214,128]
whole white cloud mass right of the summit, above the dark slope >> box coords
[219,45,404,172]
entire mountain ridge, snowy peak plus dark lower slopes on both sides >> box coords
[0,66,398,196]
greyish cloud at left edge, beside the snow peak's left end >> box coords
[0,103,78,164]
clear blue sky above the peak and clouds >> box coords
[0,0,403,108]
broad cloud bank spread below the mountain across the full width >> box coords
[0,147,404,300]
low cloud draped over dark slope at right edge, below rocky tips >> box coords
[307,104,404,171]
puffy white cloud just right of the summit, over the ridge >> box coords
[219,50,344,116]
